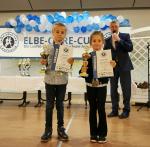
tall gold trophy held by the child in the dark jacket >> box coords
[80,46,90,77]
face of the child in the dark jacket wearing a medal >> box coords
[91,35,104,51]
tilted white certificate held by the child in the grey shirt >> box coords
[55,45,73,72]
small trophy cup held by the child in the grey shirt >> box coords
[40,44,49,72]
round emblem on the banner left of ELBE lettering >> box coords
[0,32,19,53]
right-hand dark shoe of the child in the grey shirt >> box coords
[57,127,69,141]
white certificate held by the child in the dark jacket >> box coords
[96,49,114,78]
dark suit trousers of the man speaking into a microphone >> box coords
[110,68,131,112]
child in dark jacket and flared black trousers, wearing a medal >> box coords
[79,31,115,143]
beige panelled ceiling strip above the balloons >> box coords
[0,0,150,12]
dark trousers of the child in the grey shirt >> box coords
[45,84,66,130]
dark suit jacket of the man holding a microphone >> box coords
[104,33,133,71]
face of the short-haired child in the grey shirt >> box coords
[52,25,66,43]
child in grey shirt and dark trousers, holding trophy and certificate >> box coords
[41,23,74,142]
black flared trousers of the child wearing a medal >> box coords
[87,86,107,137]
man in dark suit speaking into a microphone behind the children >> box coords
[105,21,133,119]
